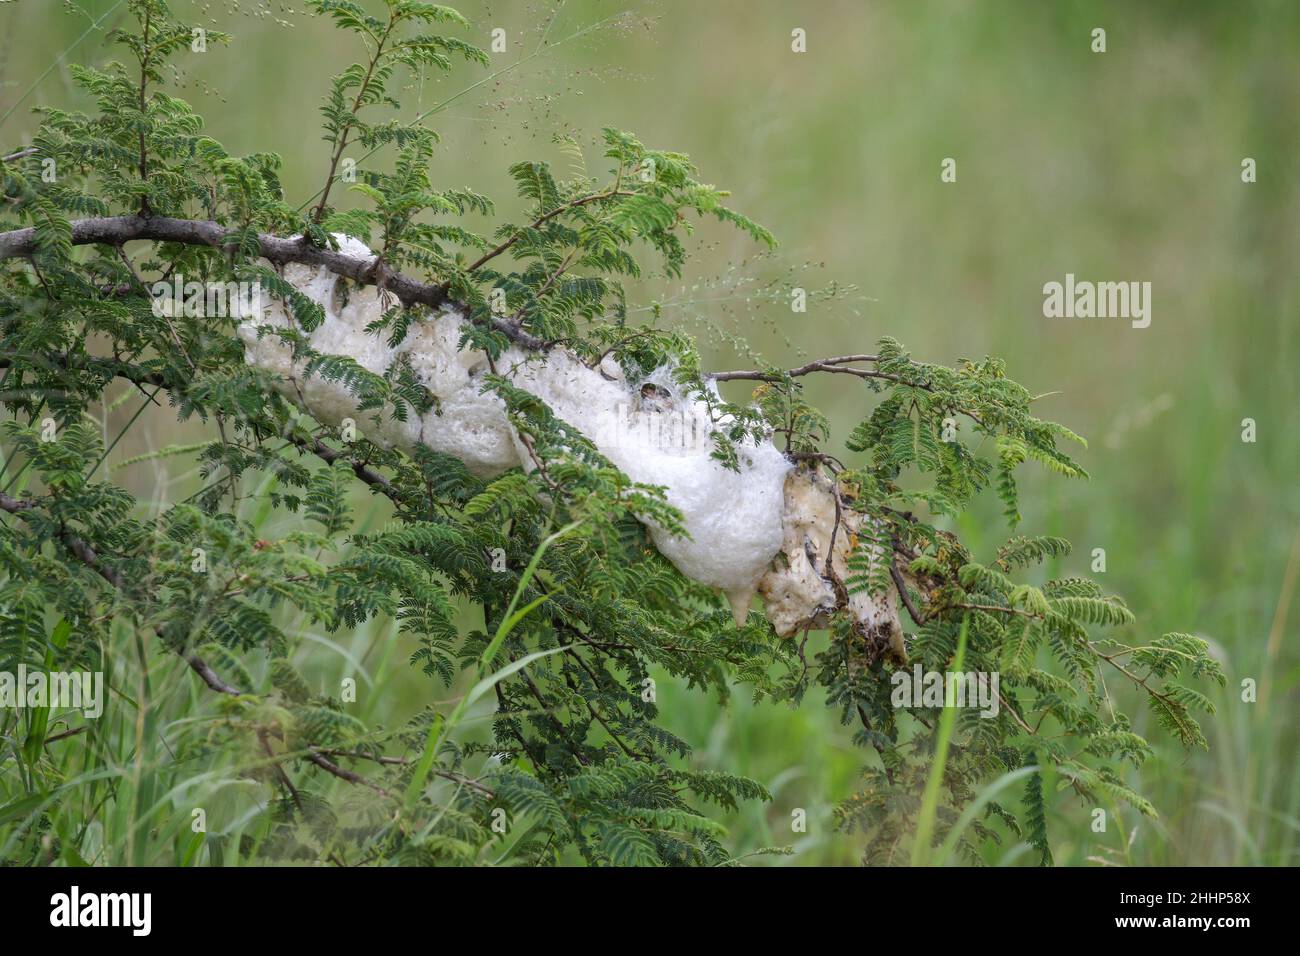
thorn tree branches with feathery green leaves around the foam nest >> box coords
[0,0,1222,864]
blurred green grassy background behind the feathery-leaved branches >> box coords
[0,0,1300,865]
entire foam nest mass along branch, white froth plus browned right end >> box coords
[239,235,904,658]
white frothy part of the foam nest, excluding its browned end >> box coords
[239,235,792,619]
